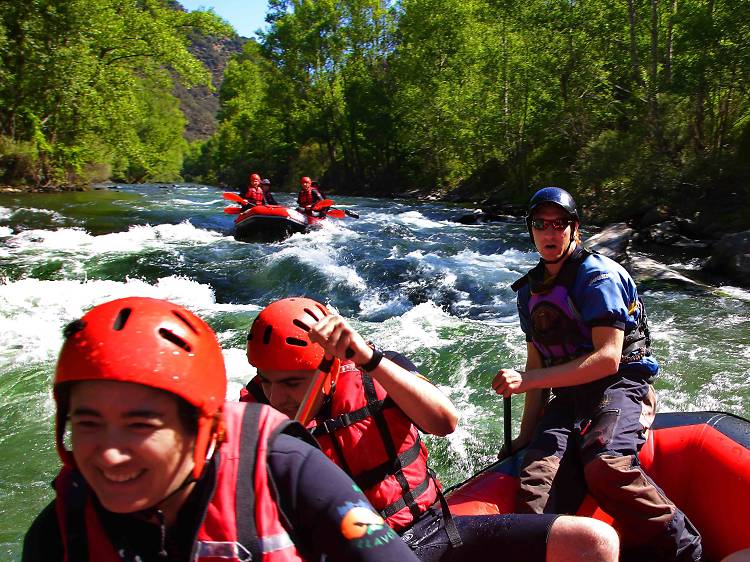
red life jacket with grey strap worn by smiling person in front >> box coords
[55,402,304,562]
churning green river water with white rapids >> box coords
[0,184,750,560]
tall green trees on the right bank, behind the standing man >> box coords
[197,0,750,226]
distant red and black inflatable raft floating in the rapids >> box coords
[234,205,325,242]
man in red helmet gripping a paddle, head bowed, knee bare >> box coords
[242,298,619,562]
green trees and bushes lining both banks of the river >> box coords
[0,0,750,230]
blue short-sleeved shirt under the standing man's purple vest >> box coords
[517,254,659,376]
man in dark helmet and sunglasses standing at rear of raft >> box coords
[492,187,701,561]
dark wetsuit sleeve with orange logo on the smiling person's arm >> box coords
[269,435,424,562]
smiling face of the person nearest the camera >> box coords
[69,381,195,513]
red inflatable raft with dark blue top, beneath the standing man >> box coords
[447,412,750,560]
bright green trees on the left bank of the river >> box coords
[0,0,231,185]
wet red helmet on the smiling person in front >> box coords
[54,297,227,478]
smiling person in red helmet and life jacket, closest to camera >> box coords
[23,298,424,562]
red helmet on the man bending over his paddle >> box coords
[247,297,339,378]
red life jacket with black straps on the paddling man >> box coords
[311,362,440,531]
